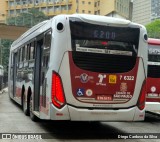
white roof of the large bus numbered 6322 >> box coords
[11,14,138,50]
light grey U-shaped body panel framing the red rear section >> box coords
[59,52,145,108]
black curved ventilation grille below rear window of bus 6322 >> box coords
[72,51,136,73]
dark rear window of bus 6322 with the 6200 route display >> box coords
[70,19,140,56]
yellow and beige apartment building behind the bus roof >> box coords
[0,0,132,23]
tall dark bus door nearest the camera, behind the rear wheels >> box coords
[33,39,43,111]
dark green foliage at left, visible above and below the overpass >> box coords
[3,8,48,72]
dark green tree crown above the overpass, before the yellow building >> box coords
[7,8,48,27]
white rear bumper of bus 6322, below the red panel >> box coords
[68,106,145,121]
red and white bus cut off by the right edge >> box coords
[146,38,160,113]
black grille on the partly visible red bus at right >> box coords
[148,65,160,78]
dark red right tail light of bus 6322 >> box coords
[137,81,146,110]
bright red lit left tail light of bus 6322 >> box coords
[52,72,66,108]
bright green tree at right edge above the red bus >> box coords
[146,20,160,38]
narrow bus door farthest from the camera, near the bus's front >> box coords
[13,52,18,97]
